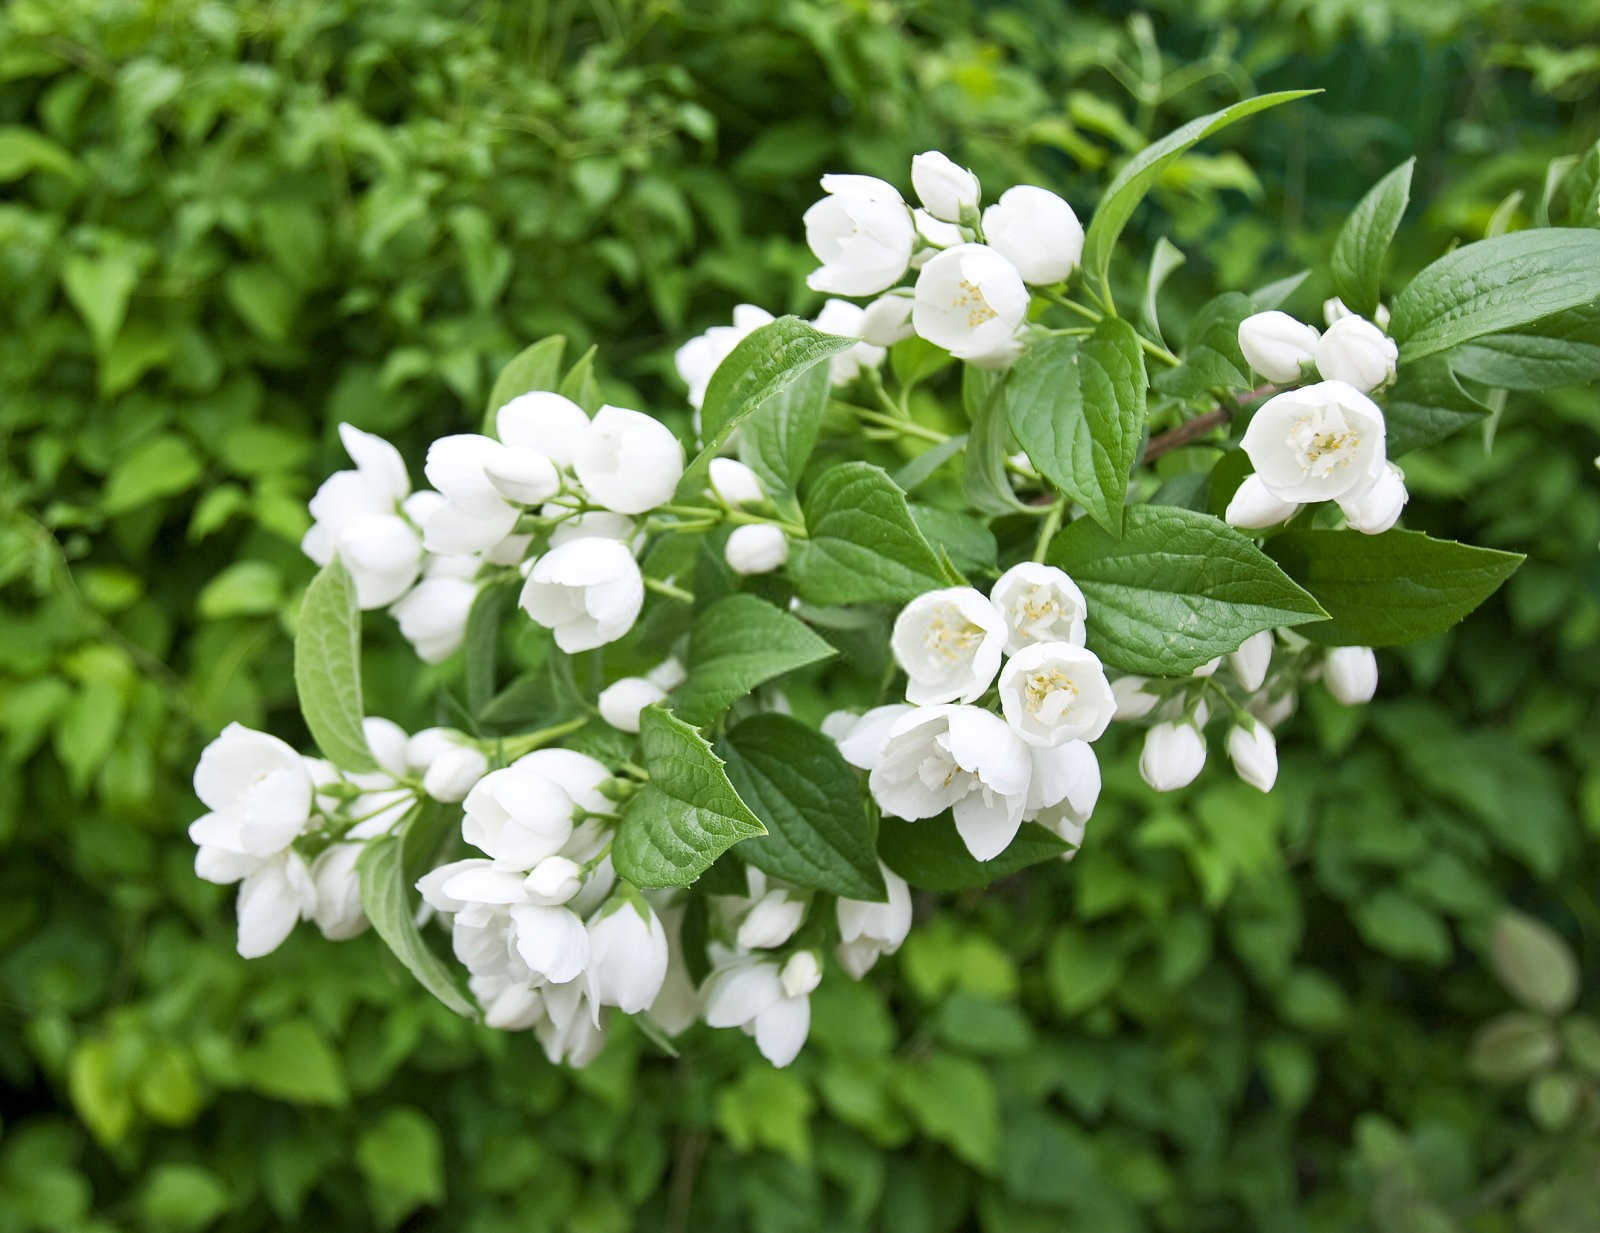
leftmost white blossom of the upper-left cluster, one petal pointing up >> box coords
[301,424,422,608]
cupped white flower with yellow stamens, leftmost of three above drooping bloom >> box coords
[890,587,1006,705]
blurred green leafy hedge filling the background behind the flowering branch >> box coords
[0,0,1600,1233]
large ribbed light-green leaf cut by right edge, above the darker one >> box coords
[1389,227,1600,361]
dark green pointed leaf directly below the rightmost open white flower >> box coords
[1266,531,1523,646]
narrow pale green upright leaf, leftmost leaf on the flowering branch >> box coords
[294,557,378,771]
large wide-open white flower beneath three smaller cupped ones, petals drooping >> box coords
[867,705,1032,860]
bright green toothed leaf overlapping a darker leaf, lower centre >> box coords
[611,707,766,886]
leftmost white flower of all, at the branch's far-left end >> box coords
[189,723,312,889]
